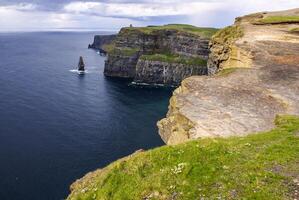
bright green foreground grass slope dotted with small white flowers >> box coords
[68,116,299,200]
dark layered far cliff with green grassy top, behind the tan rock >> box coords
[104,24,217,85]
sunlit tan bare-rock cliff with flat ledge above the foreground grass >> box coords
[158,9,299,144]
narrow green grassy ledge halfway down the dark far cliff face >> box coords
[140,54,207,66]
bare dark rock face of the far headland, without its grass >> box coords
[104,28,209,85]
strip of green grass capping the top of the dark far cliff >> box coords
[122,24,218,38]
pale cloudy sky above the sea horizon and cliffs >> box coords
[0,0,299,31]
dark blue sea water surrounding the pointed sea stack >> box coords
[0,32,171,200]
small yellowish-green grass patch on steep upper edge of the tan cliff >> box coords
[212,26,244,44]
